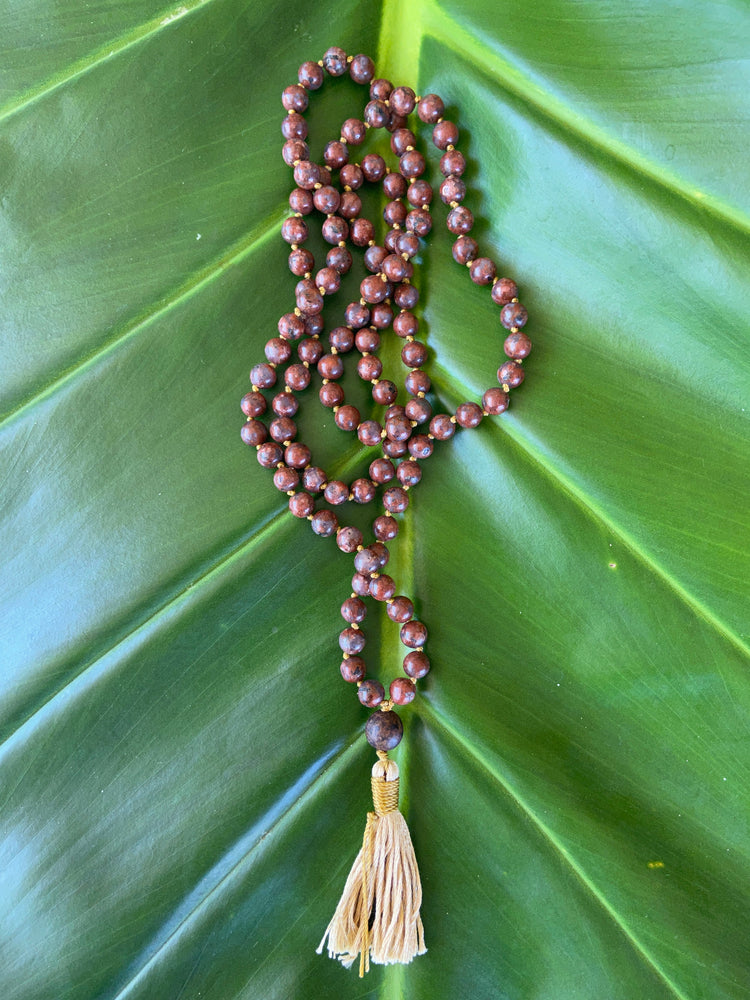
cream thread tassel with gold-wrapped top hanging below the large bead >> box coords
[317,750,427,978]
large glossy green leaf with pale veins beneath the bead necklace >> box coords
[0,0,750,1000]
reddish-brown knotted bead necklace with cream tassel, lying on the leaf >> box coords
[241,46,531,976]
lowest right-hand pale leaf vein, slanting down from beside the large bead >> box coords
[421,700,690,1000]
